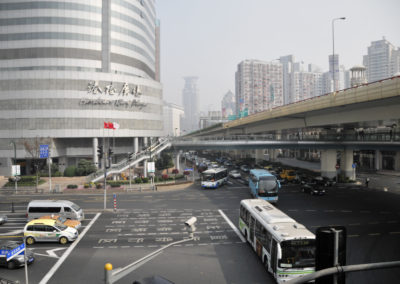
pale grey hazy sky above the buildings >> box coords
[156,0,400,111]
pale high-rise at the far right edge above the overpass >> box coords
[363,38,400,82]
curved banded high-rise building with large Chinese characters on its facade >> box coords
[0,0,163,175]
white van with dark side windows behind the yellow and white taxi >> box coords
[26,200,85,221]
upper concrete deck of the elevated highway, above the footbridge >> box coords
[188,76,400,137]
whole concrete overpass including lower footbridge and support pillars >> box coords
[182,76,400,178]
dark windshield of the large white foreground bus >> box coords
[279,239,315,268]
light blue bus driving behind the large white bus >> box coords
[249,169,281,203]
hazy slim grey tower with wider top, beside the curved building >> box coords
[182,77,199,132]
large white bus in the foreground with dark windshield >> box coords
[239,199,315,283]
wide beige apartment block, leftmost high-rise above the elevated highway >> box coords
[235,60,283,115]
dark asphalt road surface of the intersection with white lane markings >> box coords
[0,181,400,283]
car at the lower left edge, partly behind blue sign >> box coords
[0,241,35,269]
